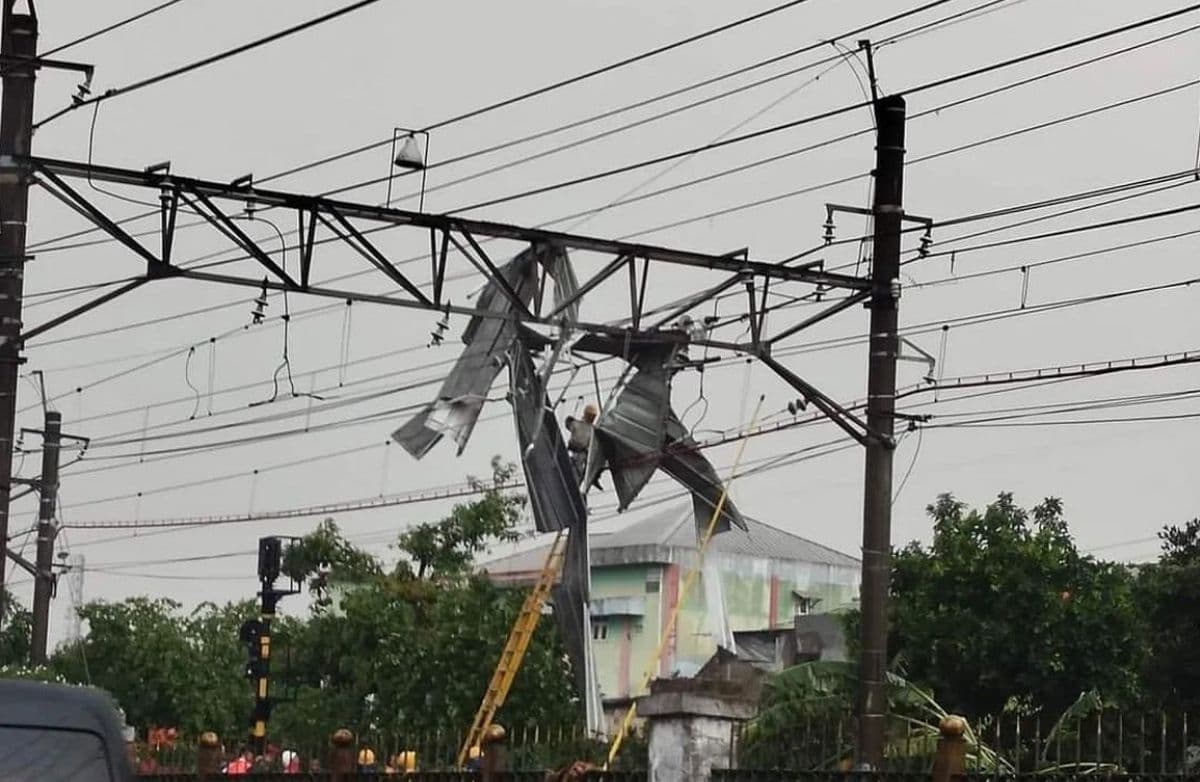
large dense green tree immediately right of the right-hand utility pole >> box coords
[873,494,1145,716]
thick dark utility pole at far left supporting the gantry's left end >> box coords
[0,0,37,621]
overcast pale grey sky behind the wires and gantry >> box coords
[10,0,1200,647]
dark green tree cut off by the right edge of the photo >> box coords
[1138,519,1200,710]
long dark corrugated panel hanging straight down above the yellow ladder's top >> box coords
[509,339,587,533]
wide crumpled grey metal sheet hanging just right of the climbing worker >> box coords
[596,344,676,511]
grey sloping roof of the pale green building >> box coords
[481,501,859,577]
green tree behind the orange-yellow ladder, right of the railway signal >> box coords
[276,462,580,742]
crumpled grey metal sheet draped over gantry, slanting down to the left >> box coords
[391,246,575,459]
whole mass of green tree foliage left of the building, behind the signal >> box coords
[12,462,582,747]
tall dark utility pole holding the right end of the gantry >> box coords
[858,95,905,770]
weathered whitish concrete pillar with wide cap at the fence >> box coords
[637,680,755,782]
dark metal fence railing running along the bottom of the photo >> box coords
[131,710,1200,782]
